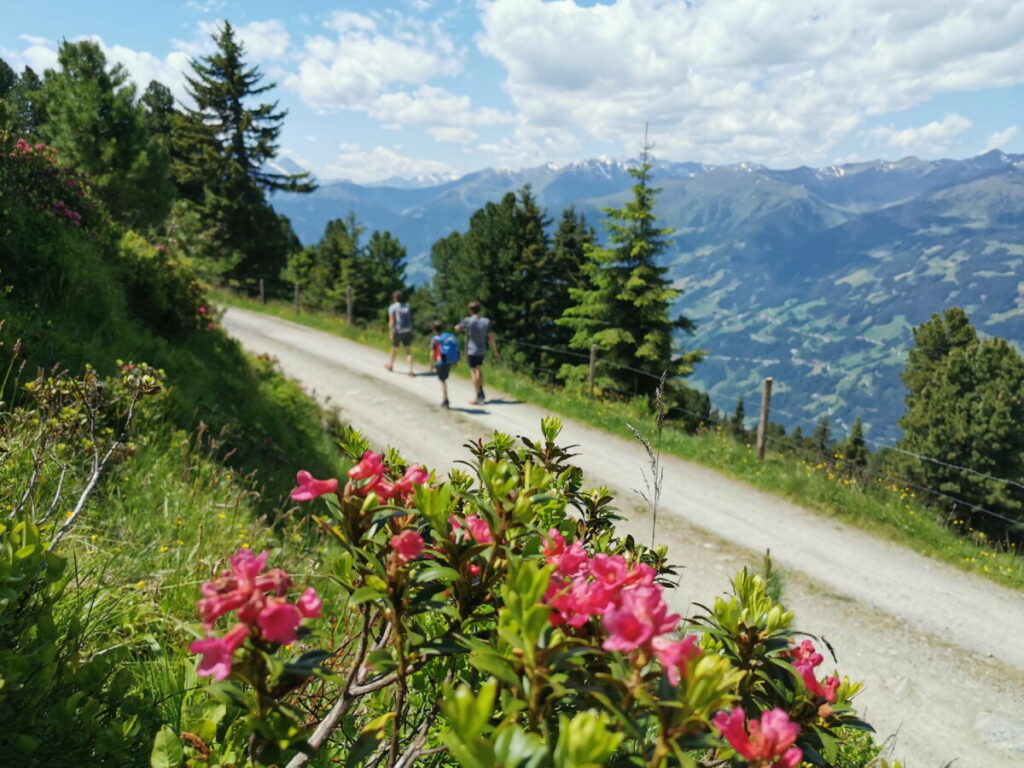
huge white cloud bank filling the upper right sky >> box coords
[477,0,1024,165]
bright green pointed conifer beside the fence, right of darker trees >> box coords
[559,142,702,396]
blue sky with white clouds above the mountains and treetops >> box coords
[0,0,1024,183]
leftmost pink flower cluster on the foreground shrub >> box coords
[188,549,323,681]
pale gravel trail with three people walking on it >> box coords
[224,309,1024,768]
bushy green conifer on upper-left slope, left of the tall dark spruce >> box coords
[40,40,174,228]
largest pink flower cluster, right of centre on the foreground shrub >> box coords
[544,528,701,685]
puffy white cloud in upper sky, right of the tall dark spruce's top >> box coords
[285,11,460,111]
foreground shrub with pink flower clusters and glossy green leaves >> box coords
[172,418,881,768]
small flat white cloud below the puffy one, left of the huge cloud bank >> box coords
[368,85,514,143]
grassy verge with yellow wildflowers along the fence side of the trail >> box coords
[213,293,1024,589]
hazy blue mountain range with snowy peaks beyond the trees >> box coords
[273,151,1024,442]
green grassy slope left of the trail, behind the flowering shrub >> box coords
[0,240,345,766]
